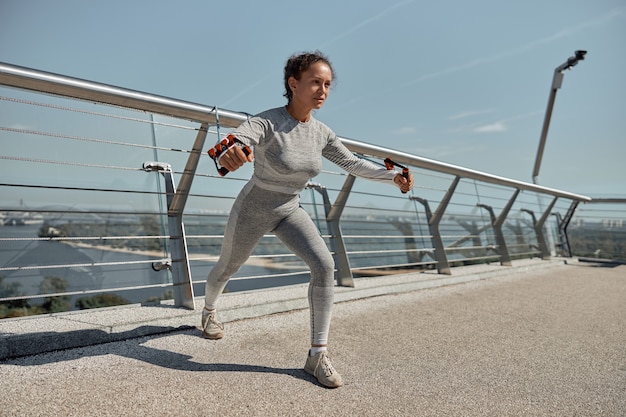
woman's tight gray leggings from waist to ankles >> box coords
[205,182,335,345]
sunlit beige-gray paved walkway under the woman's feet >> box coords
[0,261,626,417]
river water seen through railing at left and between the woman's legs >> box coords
[0,225,308,305]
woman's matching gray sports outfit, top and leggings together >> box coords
[205,107,397,345]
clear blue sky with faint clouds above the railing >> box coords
[0,0,626,198]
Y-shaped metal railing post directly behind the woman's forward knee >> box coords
[309,175,355,287]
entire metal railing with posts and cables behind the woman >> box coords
[0,64,620,311]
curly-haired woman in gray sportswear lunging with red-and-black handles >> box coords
[202,51,413,388]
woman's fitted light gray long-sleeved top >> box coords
[232,107,397,194]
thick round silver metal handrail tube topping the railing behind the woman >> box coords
[0,62,591,202]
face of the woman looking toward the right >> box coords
[289,62,333,110]
